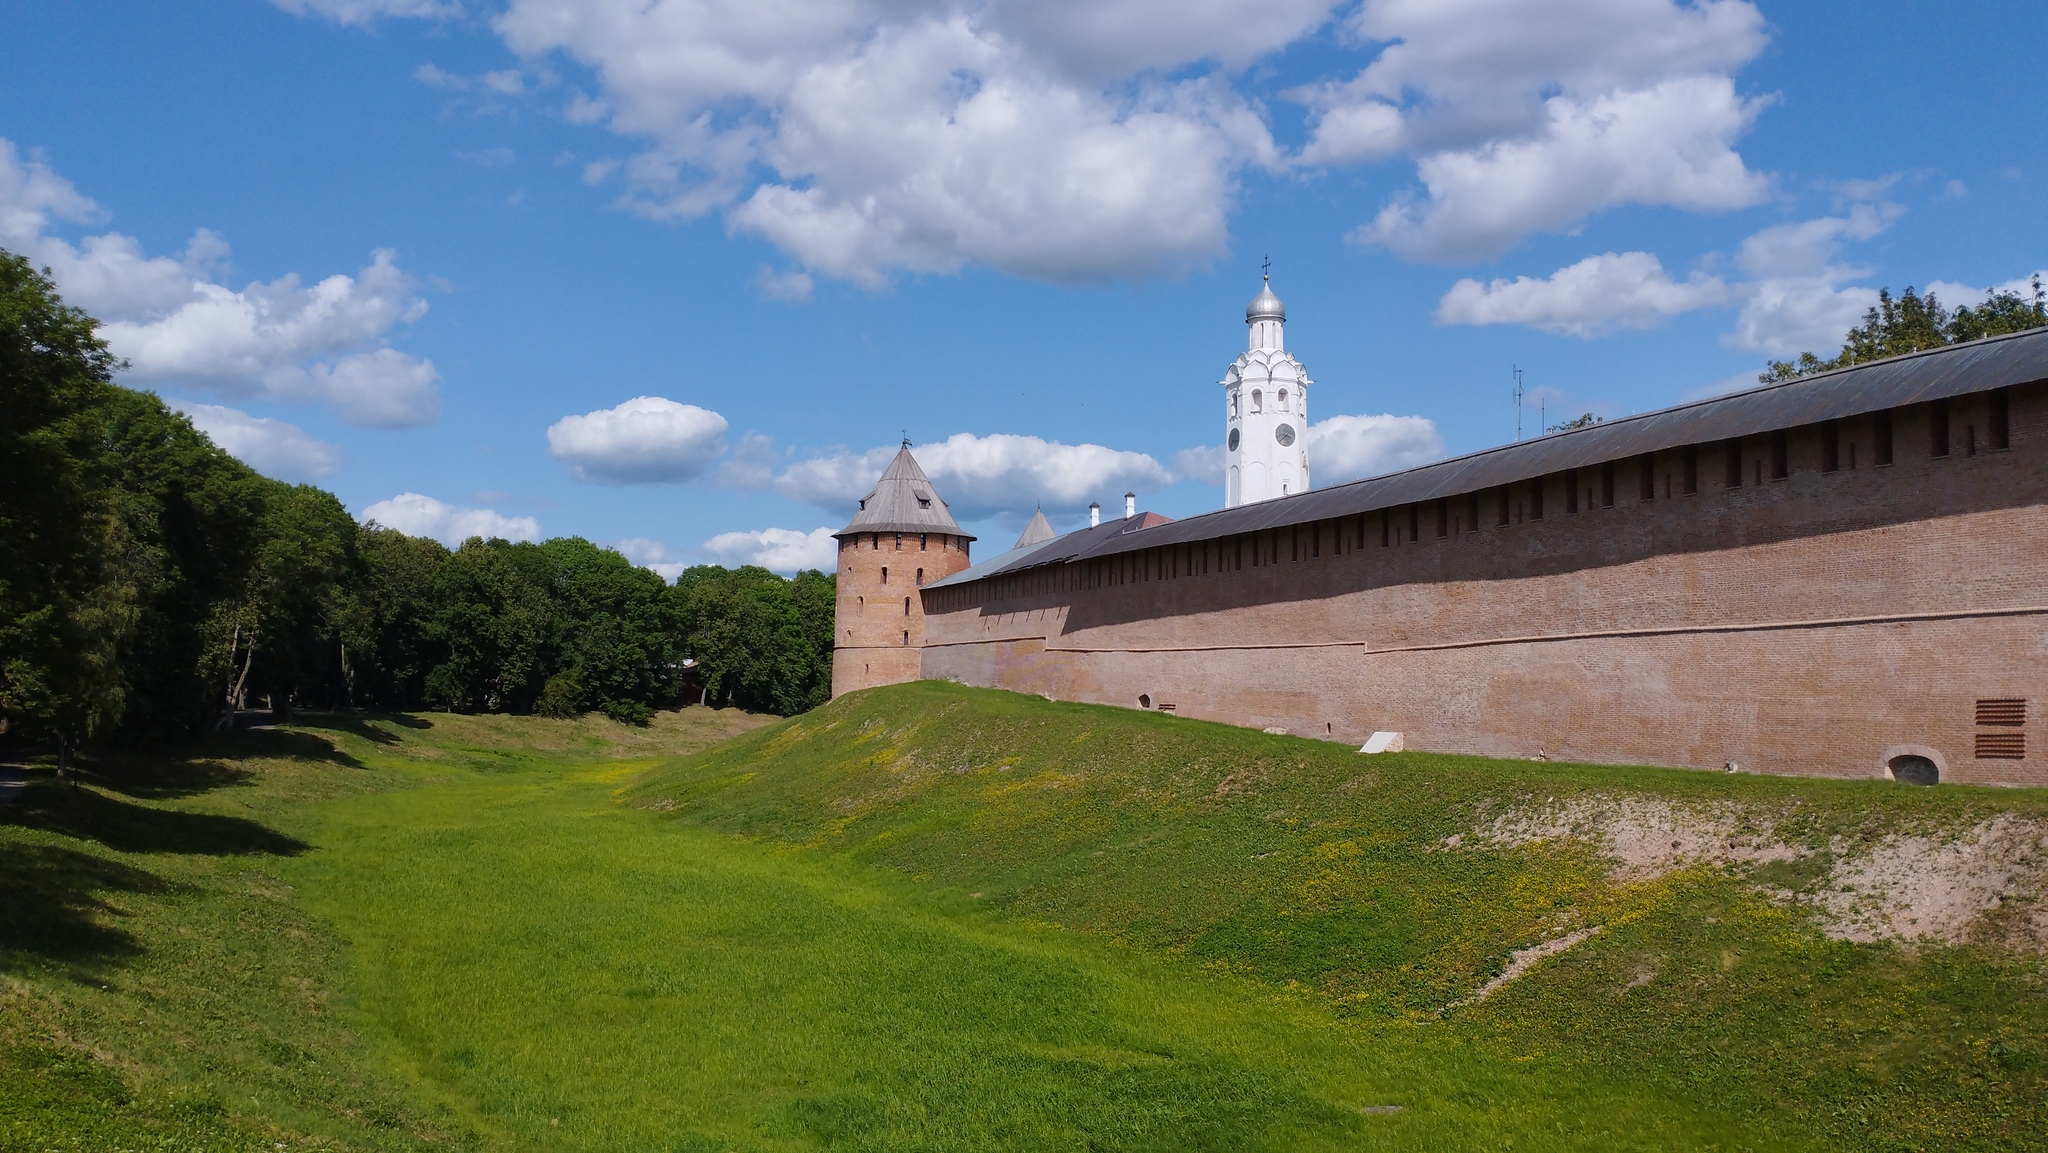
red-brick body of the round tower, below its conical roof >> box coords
[831,532,969,696]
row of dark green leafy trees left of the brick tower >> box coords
[0,252,834,750]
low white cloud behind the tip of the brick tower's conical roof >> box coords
[768,432,1176,520]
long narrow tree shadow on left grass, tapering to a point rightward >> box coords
[0,780,311,856]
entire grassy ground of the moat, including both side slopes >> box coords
[0,682,2048,1153]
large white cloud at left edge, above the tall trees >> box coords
[0,139,440,428]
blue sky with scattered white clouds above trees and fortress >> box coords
[0,0,2048,571]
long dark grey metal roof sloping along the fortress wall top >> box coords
[926,328,2048,588]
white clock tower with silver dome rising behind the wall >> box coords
[1223,281,1315,508]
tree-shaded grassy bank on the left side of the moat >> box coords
[0,709,760,1153]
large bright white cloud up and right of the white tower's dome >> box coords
[1354,76,1769,260]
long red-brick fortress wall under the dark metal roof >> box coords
[920,385,2048,784]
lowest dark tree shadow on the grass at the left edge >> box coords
[0,844,153,969]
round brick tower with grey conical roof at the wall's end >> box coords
[831,440,973,696]
